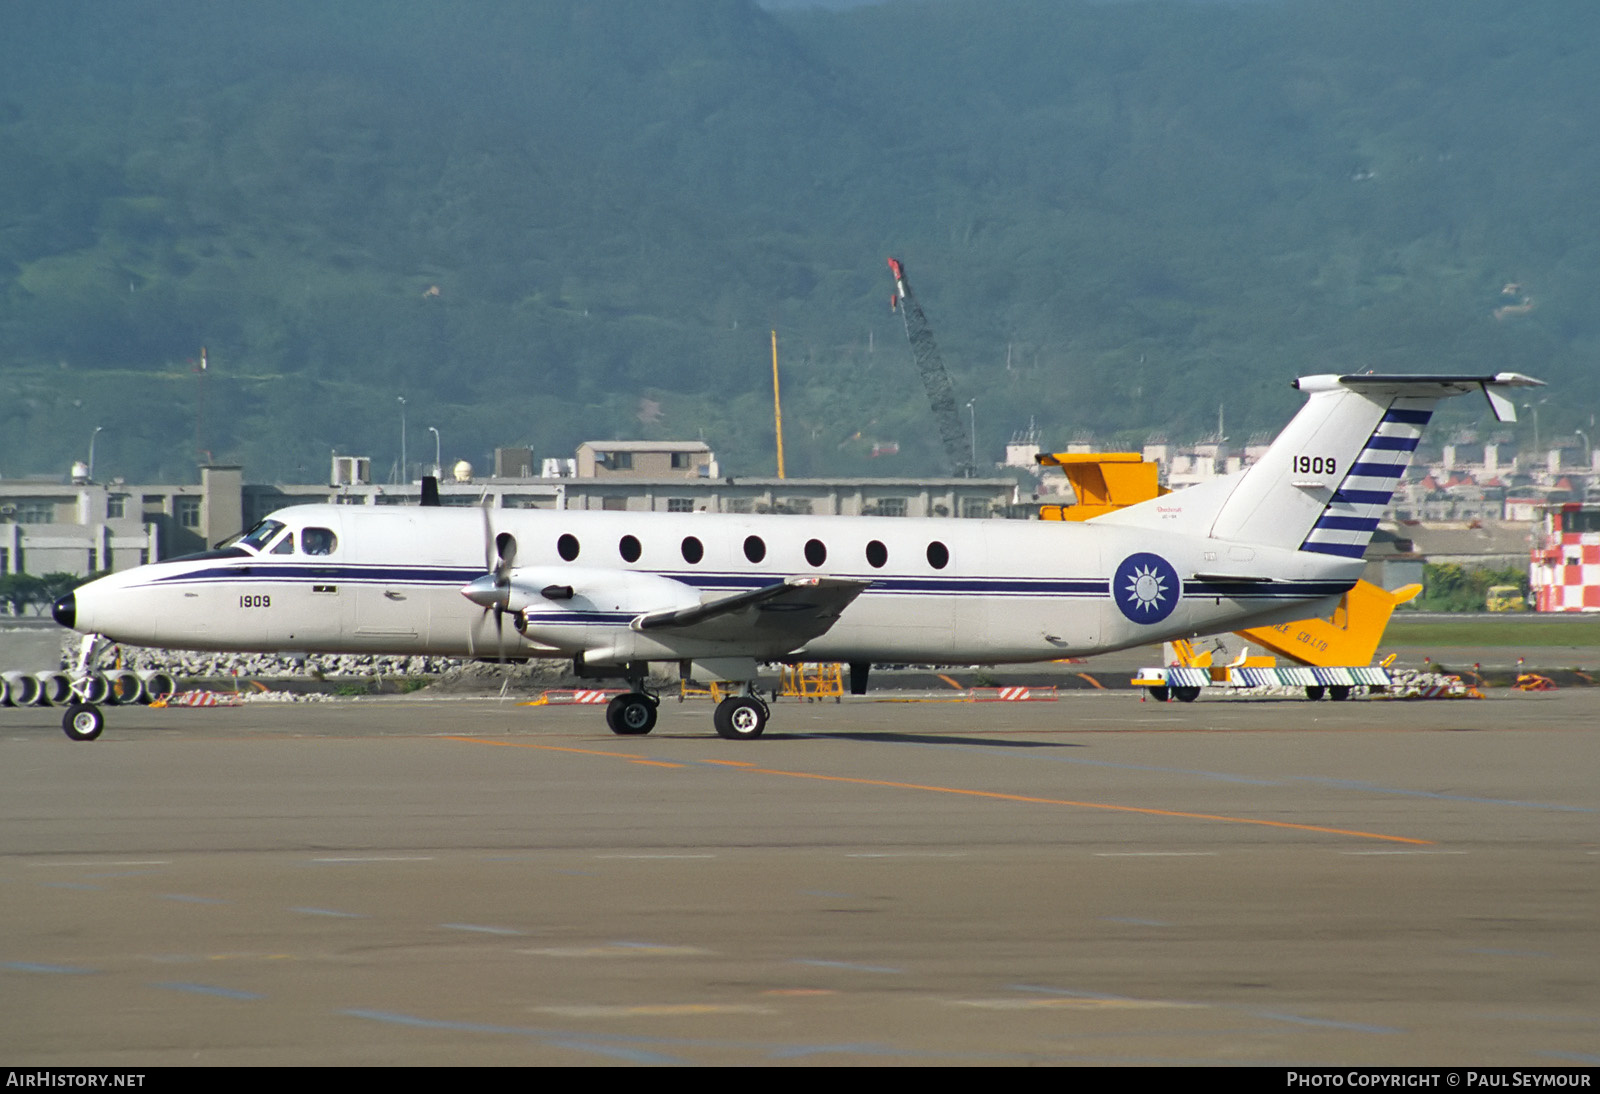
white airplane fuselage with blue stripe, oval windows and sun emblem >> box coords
[58,505,1360,664]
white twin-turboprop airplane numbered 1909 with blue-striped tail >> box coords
[54,373,1539,741]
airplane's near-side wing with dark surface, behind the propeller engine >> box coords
[630,577,872,648]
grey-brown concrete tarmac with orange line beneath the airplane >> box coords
[0,691,1600,1068]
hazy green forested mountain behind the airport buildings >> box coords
[0,0,1600,478]
